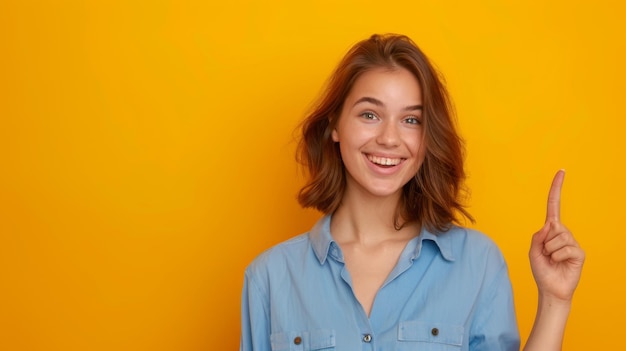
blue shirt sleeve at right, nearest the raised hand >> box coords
[469,256,520,351]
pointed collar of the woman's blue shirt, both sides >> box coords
[309,215,454,264]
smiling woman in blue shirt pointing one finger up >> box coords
[241,35,584,351]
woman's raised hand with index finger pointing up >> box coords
[529,170,585,301]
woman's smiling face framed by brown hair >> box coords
[332,68,426,201]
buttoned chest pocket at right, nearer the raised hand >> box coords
[398,321,464,351]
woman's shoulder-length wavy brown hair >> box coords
[297,34,473,231]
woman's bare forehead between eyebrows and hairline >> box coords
[345,67,422,105]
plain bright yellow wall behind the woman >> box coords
[0,0,626,350]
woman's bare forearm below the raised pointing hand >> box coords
[524,295,572,351]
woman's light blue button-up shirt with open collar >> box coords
[240,216,519,351]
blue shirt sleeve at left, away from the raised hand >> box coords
[239,271,271,351]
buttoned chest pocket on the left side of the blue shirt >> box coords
[270,329,335,351]
